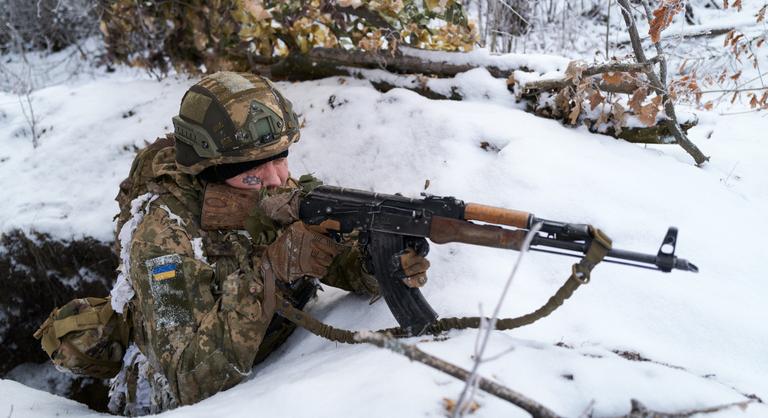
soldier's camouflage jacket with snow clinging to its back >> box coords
[110,140,368,415]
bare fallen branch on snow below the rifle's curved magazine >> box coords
[355,331,560,418]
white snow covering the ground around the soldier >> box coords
[0,20,768,418]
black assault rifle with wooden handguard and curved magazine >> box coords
[299,186,698,335]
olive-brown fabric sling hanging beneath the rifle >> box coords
[276,226,611,344]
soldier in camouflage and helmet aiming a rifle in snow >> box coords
[104,72,429,415]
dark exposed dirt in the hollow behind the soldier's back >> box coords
[0,230,118,410]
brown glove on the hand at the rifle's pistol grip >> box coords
[261,222,346,283]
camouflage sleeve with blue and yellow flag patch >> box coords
[130,205,271,405]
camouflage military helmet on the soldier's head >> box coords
[173,72,299,175]
